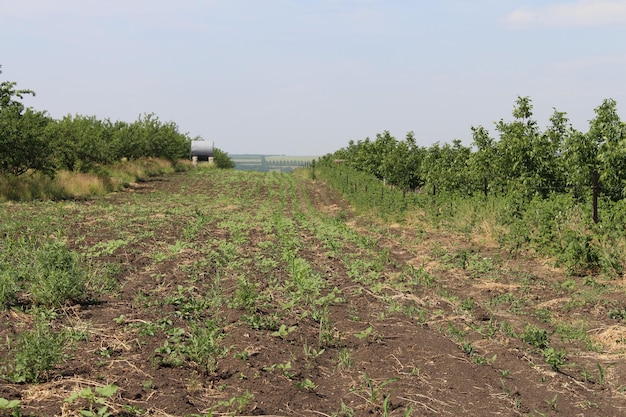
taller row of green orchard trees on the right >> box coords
[320,97,626,201]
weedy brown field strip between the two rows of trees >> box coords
[0,169,626,417]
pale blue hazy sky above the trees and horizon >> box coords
[0,0,626,155]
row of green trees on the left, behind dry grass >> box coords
[0,69,222,175]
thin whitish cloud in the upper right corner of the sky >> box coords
[502,0,626,28]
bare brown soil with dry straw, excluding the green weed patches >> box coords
[0,173,626,416]
